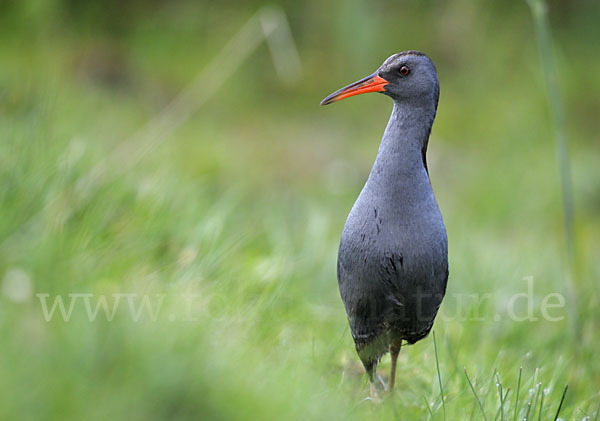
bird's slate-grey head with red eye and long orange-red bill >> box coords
[321,51,440,107]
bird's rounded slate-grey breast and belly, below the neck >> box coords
[338,185,448,352]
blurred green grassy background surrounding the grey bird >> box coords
[0,0,600,420]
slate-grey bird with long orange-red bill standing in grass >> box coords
[321,50,449,401]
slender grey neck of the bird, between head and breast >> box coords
[367,101,436,191]
